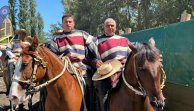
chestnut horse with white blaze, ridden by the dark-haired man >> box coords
[9,37,82,111]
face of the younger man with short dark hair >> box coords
[62,17,75,32]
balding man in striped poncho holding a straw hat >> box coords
[92,18,131,111]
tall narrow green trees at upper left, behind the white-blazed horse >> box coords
[9,0,45,42]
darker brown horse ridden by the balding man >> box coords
[108,39,165,111]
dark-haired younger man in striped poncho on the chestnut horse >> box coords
[46,14,97,111]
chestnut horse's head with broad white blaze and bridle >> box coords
[9,37,46,105]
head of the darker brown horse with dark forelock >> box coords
[125,38,165,111]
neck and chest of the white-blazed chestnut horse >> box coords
[36,48,82,111]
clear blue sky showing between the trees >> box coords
[0,0,64,32]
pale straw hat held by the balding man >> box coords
[92,59,122,81]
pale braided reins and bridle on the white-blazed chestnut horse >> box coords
[13,56,87,111]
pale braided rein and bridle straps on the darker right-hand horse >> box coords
[122,53,166,96]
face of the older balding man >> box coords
[104,22,116,36]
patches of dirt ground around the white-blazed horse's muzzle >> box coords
[0,77,39,111]
